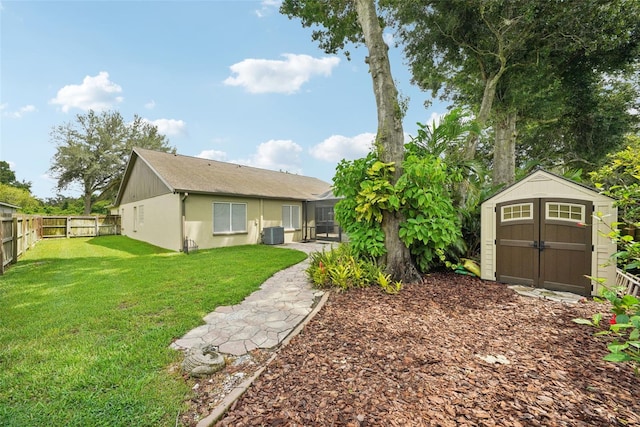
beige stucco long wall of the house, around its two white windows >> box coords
[185,194,302,249]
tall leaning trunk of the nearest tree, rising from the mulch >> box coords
[355,0,420,283]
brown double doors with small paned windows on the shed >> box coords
[496,198,593,295]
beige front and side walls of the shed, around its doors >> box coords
[480,171,618,295]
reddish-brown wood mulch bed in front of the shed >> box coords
[182,273,640,426]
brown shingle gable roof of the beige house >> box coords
[116,148,331,204]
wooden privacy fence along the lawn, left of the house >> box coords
[0,214,120,274]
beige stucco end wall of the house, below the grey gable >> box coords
[118,194,182,251]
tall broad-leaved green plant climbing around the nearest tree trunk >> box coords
[334,152,461,271]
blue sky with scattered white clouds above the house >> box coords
[0,0,446,198]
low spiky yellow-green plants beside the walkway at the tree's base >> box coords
[307,243,402,294]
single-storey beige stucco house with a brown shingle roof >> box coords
[112,148,340,251]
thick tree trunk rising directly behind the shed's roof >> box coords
[493,111,517,185]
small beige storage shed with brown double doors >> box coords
[480,169,618,295]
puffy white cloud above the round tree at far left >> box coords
[49,71,124,113]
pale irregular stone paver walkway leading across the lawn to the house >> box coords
[171,242,338,356]
